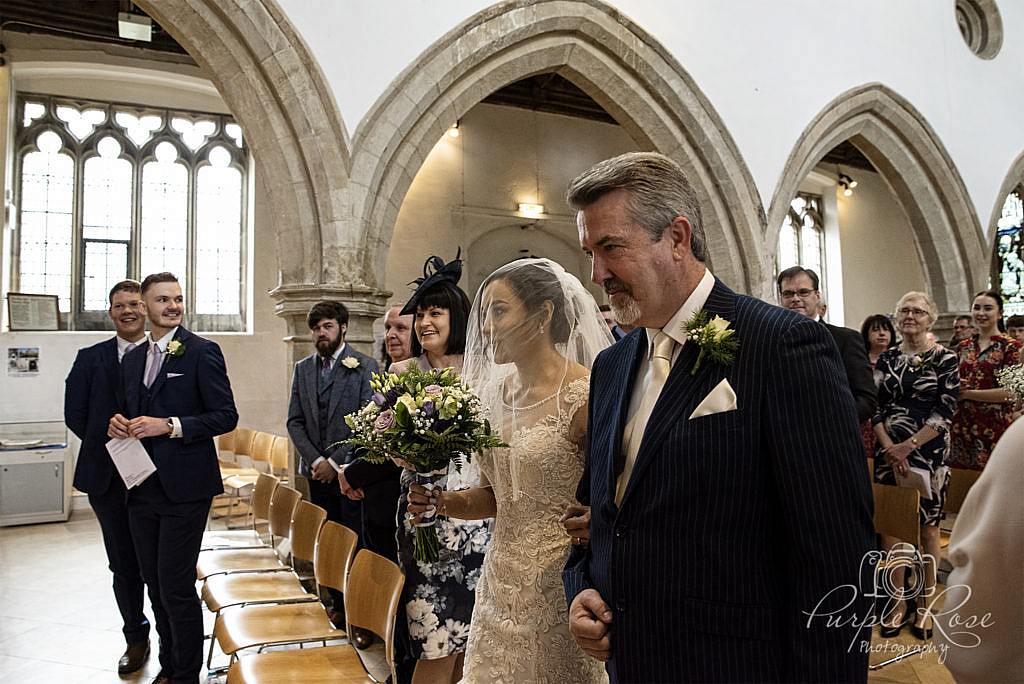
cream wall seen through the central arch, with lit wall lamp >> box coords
[387,100,636,302]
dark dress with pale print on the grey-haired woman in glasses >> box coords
[871,346,959,525]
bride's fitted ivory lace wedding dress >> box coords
[463,377,607,684]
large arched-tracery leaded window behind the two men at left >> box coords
[11,94,249,331]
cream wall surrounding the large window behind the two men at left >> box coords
[0,41,291,434]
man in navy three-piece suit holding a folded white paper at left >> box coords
[108,272,239,684]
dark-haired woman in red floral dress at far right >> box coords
[949,291,1021,470]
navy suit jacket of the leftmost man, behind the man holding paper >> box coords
[65,337,124,497]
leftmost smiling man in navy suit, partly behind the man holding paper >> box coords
[65,281,150,675]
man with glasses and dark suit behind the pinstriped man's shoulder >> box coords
[775,266,879,423]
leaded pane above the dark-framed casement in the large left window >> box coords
[82,137,132,241]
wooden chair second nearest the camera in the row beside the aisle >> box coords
[213,522,358,661]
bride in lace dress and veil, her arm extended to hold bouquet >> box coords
[409,258,612,683]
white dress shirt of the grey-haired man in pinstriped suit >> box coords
[615,268,715,505]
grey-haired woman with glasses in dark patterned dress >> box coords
[871,292,959,640]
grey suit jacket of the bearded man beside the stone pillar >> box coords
[288,344,377,476]
